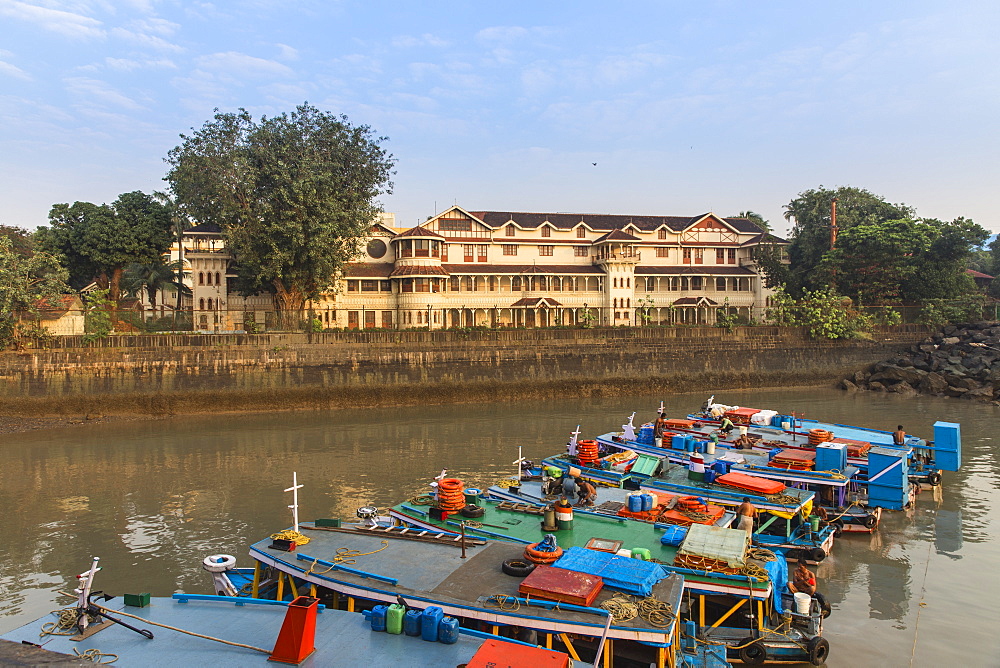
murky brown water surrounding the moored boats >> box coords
[0,388,1000,667]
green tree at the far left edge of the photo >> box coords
[0,236,68,347]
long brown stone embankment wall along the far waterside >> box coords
[0,326,927,415]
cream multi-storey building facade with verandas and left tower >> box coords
[168,206,786,331]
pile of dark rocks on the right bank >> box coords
[841,322,1000,401]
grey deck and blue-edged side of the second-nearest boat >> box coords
[250,513,683,644]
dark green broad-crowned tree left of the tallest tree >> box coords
[38,191,171,304]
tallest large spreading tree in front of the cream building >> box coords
[166,104,395,324]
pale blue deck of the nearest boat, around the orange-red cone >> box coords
[0,598,524,668]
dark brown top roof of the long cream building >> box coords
[469,211,762,234]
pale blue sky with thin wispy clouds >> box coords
[0,0,1000,237]
